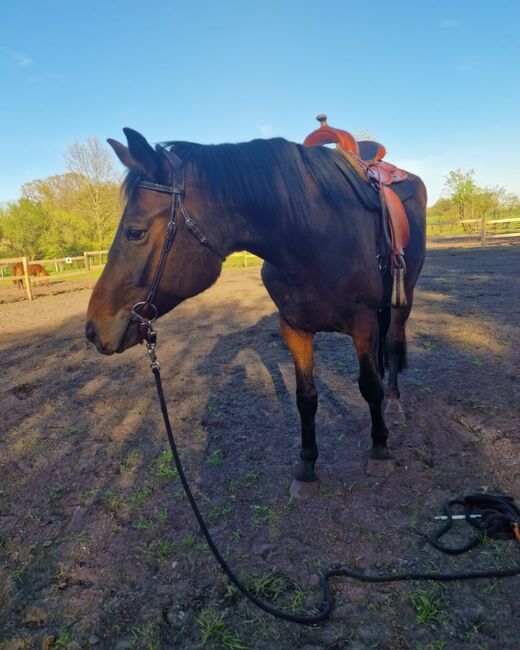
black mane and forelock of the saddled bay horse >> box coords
[124,138,373,224]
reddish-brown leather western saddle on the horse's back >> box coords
[303,114,410,307]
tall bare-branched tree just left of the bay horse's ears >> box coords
[65,137,121,248]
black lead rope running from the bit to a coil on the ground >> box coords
[143,321,520,625]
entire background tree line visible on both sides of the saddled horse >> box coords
[0,138,520,259]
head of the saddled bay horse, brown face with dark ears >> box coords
[86,129,222,354]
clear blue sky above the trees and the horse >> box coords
[0,0,520,204]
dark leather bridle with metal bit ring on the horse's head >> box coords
[132,145,226,343]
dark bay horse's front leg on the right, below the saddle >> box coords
[352,310,393,474]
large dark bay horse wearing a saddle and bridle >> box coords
[86,129,426,496]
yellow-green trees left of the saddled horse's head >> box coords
[0,138,122,259]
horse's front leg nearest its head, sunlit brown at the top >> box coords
[280,317,318,498]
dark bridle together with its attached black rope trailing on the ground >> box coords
[132,148,520,625]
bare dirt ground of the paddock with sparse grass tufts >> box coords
[0,246,520,650]
